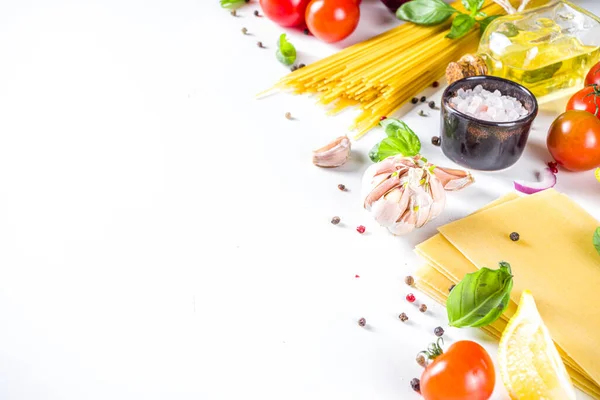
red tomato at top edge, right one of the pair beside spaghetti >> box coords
[306,0,360,43]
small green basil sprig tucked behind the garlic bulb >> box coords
[369,118,421,162]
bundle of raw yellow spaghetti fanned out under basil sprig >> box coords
[262,1,510,139]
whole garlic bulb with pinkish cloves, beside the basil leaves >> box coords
[363,155,474,235]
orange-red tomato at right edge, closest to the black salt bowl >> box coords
[546,110,600,171]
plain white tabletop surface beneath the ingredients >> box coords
[0,0,600,400]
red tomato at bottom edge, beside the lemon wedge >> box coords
[421,340,496,400]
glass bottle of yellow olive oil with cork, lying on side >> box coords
[446,0,600,103]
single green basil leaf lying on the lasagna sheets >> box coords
[446,261,513,328]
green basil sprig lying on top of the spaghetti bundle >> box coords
[396,0,498,39]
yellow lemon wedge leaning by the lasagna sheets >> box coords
[498,290,575,400]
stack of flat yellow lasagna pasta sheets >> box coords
[416,190,600,398]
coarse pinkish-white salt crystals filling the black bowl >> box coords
[450,85,529,122]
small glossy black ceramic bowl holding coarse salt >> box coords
[441,76,538,171]
